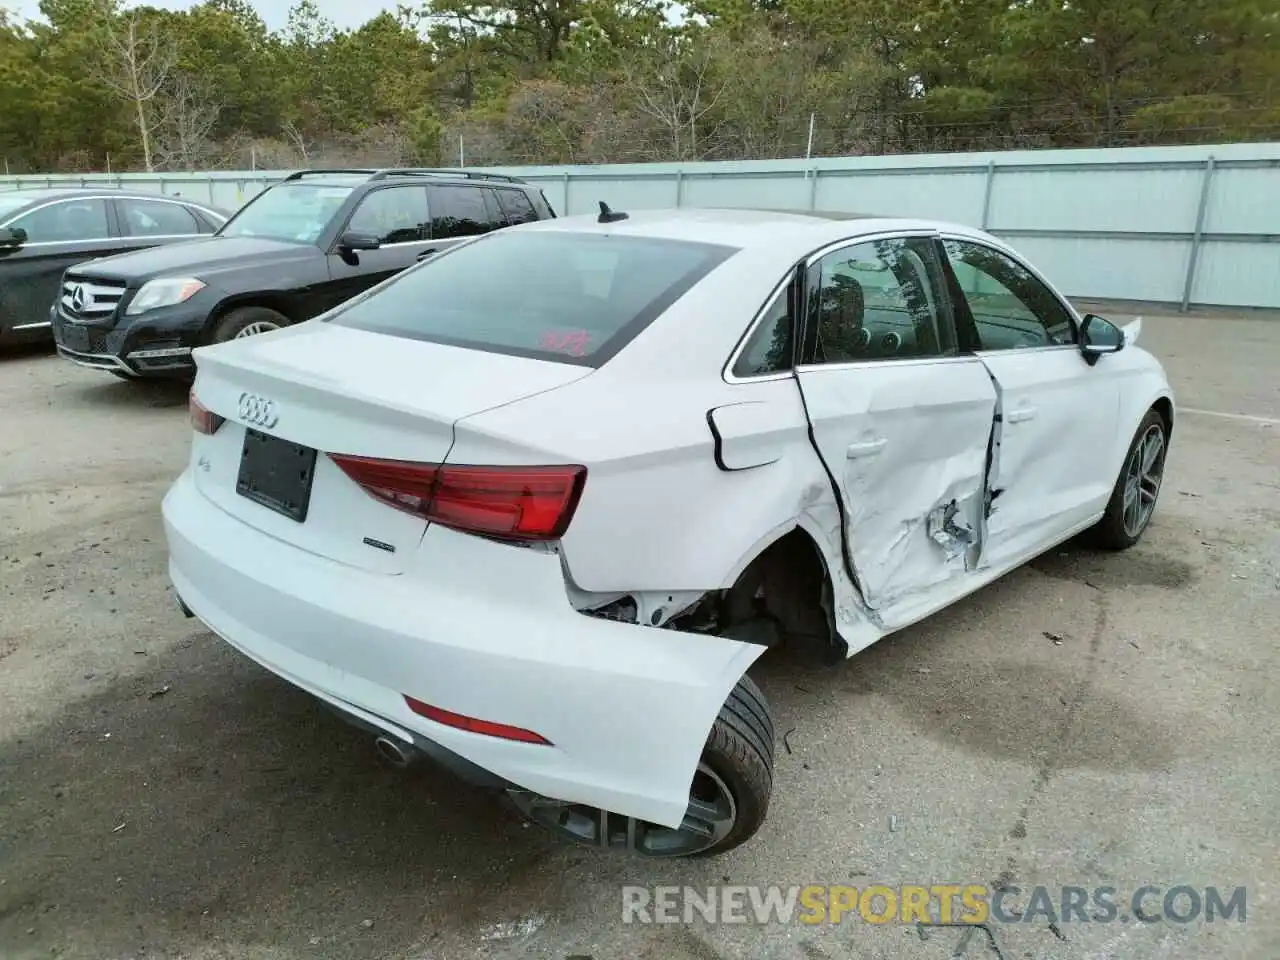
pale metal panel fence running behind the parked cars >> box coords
[0,143,1280,307]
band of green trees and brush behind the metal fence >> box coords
[0,0,1280,173]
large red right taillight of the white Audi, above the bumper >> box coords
[329,453,586,540]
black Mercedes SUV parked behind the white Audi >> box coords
[50,169,556,379]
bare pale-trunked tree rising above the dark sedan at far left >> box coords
[97,6,178,172]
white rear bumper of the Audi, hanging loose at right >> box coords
[164,472,763,827]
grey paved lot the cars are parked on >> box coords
[0,314,1280,960]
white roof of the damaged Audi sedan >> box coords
[512,207,975,251]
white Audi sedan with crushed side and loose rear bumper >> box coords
[164,204,1174,856]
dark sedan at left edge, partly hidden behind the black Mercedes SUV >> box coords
[0,188,230,344]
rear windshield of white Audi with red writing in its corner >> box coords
[330,229,737,366]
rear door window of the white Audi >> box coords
[806,237,956,364]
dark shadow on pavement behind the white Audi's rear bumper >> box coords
[0,632,557,956]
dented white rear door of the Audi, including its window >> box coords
[796,237,996,612]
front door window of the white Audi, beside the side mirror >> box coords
[943,239,1075,349]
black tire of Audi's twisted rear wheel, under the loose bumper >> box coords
[691,676,774,858]
